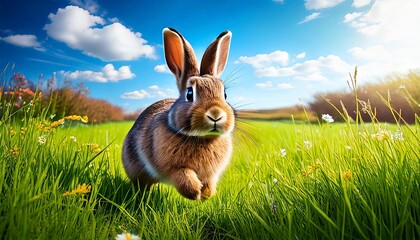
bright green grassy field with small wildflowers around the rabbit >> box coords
[0,102,420,239]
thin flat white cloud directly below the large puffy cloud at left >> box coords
[63,64,136,83]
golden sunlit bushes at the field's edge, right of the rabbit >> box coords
[309,72,420,123]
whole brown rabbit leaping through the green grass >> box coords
[122,28,235,200]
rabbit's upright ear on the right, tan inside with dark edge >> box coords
[200,31,232,77]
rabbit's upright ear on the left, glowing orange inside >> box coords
[163,28,199,93]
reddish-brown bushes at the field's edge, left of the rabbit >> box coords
[0,73,138,123]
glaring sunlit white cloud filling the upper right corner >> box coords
[344,0,420,81]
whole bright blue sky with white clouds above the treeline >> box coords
[0,0,420,111]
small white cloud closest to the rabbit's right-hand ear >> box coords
[239,51,289,68]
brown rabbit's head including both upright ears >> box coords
[163,28,235,137]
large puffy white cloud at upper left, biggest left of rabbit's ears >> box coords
[44,6,156,61]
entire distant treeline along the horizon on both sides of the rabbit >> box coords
[0,67,420,123]
